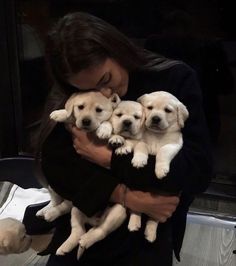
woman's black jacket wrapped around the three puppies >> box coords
[42,61,212,258]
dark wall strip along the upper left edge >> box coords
[0,0,21,157]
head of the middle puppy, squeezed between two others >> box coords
[111,101,145,138]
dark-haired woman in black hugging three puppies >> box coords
[39,12,211,266]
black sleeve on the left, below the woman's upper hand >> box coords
[41,124,119,216]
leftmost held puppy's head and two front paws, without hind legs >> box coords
[50,91,120,139]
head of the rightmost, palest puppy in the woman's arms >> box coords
[138,91,189,133]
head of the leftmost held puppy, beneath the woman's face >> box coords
[65,91,120,132]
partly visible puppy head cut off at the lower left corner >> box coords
[0,218,32,255]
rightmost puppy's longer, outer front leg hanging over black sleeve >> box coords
[155,144,182,179]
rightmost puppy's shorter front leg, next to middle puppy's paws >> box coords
[131,141,148,168]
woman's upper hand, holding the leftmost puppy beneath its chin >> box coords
[70,126,112,168]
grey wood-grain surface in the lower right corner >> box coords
[174,221,236,266]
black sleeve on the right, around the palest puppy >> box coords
[111,67,212,194]
